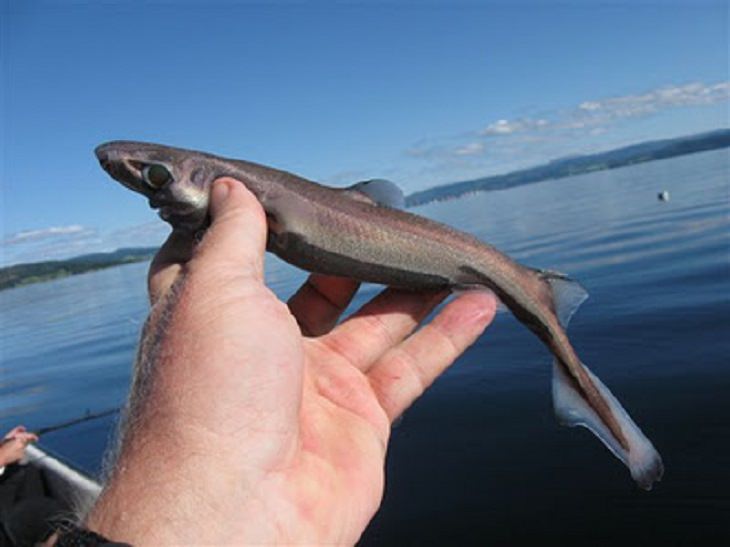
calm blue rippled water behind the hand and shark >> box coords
[0,151,730,545]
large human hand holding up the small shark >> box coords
[87,179,495,545]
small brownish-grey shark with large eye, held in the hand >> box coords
[96,141,664,490]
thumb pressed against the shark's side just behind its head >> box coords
[191,177,267,281]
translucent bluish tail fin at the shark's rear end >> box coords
[553,360,664,490]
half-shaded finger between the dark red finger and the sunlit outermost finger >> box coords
[317,289,448,371]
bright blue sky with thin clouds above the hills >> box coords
[0,0,730,265]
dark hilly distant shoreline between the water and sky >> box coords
[0,129,730,291]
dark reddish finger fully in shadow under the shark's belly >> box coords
[288,274,360,336]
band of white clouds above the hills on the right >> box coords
[400,81,730,191]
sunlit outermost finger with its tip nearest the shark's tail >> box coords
[368,292,497,421]
